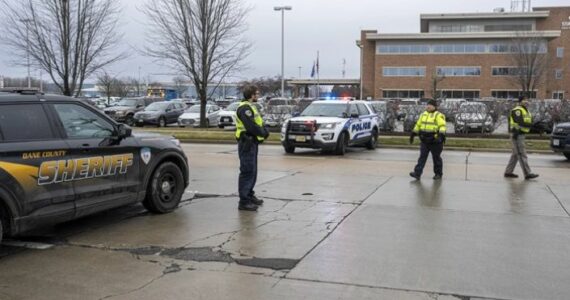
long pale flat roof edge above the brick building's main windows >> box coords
[366,30,561,40]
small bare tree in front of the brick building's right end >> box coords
[508,32,548,97]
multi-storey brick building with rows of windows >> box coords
[357,7,570,99]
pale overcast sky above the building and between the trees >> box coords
[0,0,570,81]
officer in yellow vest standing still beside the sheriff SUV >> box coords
[236,85,269,211]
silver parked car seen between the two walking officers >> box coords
[455,102,495,133]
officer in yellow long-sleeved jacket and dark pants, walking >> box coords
[410,99,447,180]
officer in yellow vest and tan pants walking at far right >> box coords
[505,96,538,180]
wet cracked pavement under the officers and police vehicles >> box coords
[0,144,570,299]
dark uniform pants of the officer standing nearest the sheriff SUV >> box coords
[238,138,259,204]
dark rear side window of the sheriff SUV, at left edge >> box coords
[0,104,55,141]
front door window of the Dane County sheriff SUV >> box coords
[54,104,114,139]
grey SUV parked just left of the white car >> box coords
[134,100,186,127]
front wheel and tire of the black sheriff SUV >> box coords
[143,162,184,214]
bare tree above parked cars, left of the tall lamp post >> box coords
[144,0,251,127]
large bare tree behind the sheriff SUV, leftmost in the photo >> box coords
[0,0,124,96]
